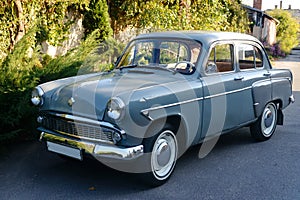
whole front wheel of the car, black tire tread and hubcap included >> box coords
[141,126,178,187]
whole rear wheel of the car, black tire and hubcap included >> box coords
[250,102,278,141]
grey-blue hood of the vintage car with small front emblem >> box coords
[42,70,178,120]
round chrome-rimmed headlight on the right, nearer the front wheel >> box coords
[107,97,125,120]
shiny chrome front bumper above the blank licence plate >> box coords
[40,132,144,160]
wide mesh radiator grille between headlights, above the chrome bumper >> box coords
[41,115,113,142]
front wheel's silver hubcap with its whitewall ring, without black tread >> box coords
[151,130,177,180]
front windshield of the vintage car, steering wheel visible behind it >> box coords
[117,38,201,74]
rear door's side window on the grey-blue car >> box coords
[238,44,263,70]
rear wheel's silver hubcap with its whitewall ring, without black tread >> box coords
[261,104,276,137]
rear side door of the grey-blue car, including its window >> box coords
[237,42,272,118]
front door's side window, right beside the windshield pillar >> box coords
[205,44,234,74]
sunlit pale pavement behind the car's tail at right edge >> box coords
[272,48,300,91]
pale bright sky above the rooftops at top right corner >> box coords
[242,0,300,10]
